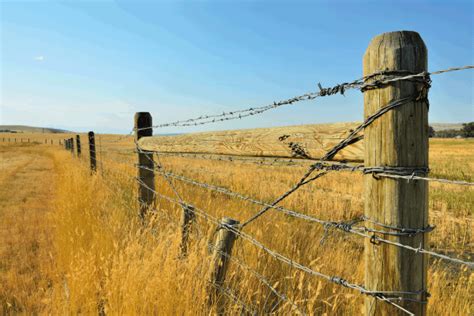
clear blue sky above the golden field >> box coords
[0,0,474,133]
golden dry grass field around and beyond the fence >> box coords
[0,135,474,315]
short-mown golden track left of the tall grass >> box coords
[0,144,55,314]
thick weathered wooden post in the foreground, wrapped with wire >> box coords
[363,31,428,315]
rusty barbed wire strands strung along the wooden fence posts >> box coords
[44,31,474,315]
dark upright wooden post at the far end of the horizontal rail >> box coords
[135,112,155,218]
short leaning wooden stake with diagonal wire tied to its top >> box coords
[207,217,239,315]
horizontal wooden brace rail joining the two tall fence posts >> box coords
[139,123,363,161]
